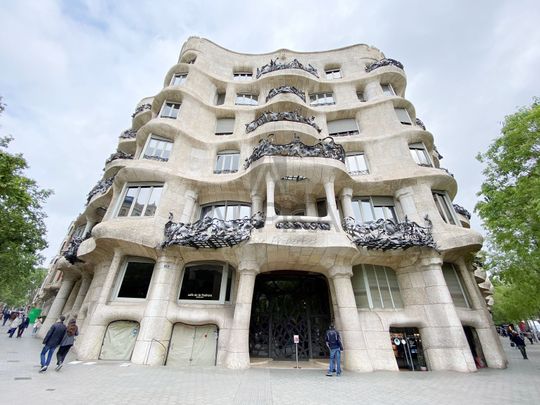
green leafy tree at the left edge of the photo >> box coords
[0,98,51,305]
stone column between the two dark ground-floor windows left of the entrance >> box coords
[131,255,180,366]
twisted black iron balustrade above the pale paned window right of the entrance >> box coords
[343,215,437,251]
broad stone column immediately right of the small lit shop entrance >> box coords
[396,255,476,372]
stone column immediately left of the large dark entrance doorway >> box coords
[225,263,259,369]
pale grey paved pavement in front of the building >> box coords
[0,327,540,405]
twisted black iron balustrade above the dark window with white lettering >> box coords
[161,212,264,249]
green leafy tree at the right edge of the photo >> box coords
[475,98,540,322]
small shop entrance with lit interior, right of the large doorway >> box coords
[390,328,427,371]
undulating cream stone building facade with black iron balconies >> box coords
[39,37,506,372]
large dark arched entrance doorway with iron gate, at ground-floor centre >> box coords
[249,271,331,360]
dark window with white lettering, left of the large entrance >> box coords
[178,263,234,303]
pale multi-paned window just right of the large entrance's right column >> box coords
[351,264,403,309]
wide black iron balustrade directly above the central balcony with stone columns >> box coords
[244,134,345,169]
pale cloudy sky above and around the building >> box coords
[0,0,540,264]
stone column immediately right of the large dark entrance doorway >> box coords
[329,266,373,371]
